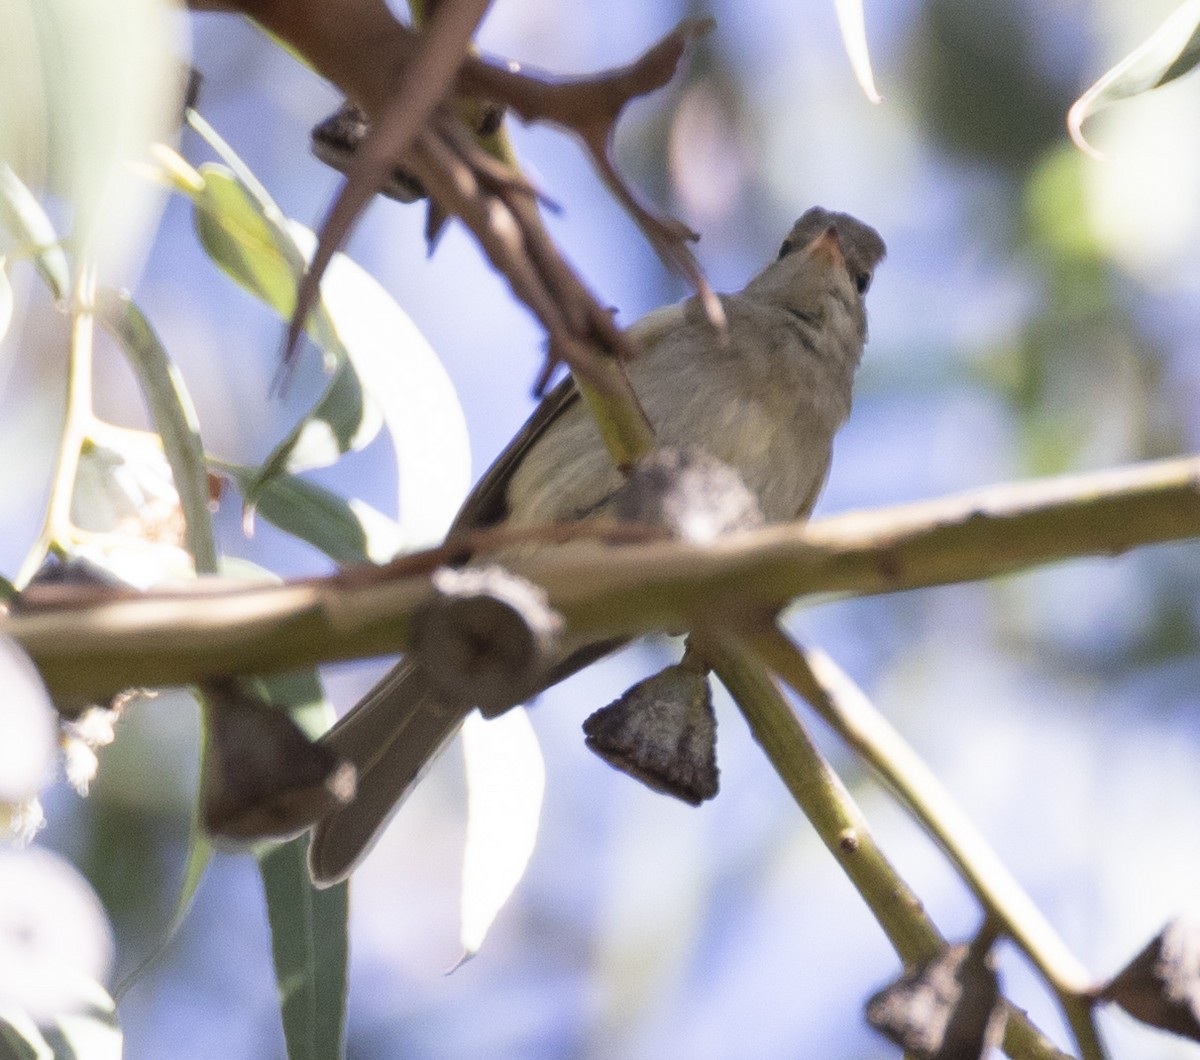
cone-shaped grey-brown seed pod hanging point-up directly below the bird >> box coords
[583,665,719,806]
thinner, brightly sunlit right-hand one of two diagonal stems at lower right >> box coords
[751,627,1105,1060]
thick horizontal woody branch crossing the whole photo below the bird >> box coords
[9,457,1200,697]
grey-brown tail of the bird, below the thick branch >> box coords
[308,660,467,886]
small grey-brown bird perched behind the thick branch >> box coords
[308,206,886,885]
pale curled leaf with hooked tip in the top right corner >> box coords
[1067,0,1200,157]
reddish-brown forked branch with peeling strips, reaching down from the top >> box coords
[191,0,725,467]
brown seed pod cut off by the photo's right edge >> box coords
[1099,918,1200,1042]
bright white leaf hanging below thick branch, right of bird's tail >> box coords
[462,707,546,957]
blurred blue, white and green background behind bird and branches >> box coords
[0,0,1200,1060]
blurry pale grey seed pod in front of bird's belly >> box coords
[613,449,763,543]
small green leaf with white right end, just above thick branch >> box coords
[211,461,401,567]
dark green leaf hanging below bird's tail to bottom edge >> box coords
[259,833,349,1060]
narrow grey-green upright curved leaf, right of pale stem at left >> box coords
[100,292,217,574]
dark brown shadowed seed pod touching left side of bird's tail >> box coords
[200,681,356,839]
